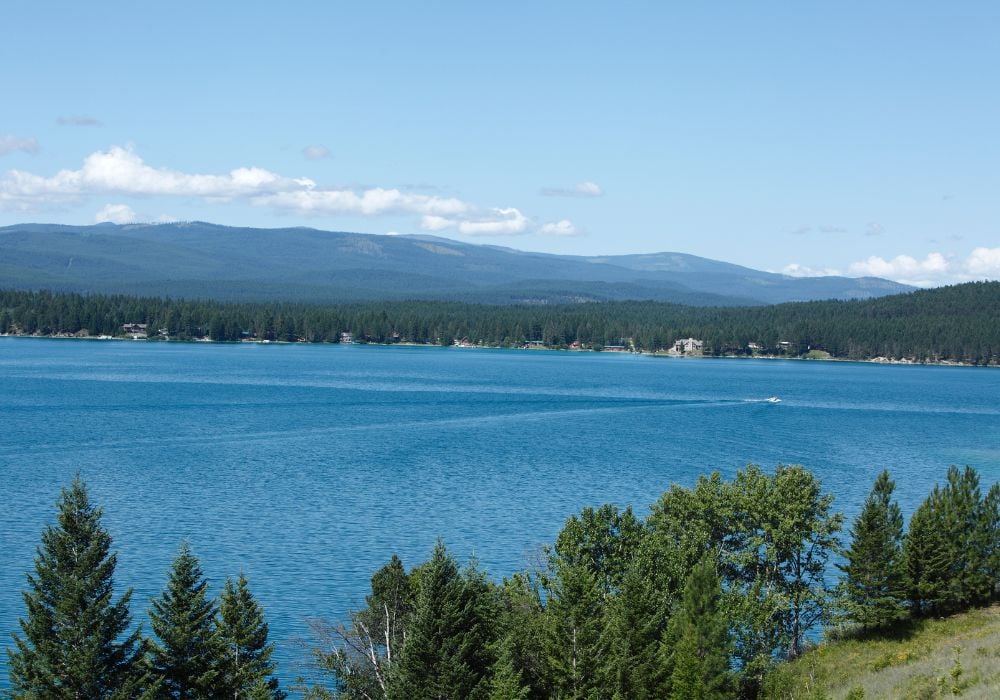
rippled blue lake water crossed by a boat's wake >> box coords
[0,338,1000,685]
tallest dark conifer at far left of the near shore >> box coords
[7,476,148,698]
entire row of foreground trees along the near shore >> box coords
[8,465,1000,700]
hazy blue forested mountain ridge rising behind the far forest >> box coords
[0,222,913,306]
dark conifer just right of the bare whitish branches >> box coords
[389,542,491,700]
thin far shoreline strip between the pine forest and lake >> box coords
[0,333,1000,369]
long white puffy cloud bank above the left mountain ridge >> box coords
[0,146,575,236]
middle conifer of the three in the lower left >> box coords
[149,542,221,699]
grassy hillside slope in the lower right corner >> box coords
[766,605,1000,700]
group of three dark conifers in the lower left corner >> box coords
[6,477,287,700]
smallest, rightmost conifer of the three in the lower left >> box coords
[216,572,286,700]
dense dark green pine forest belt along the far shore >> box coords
[0,282,1000,365]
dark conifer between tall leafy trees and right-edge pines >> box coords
[837,471,906,627]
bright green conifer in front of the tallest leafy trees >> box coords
[662,555,732,700]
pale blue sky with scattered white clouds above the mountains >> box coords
[0,0,1000,286]
